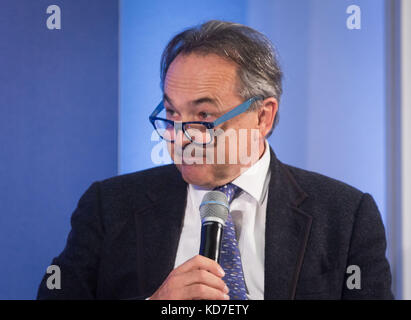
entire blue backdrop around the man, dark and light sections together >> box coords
[0,0,392,299]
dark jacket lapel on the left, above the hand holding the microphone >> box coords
[135,164,187,297]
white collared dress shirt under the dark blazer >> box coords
[174,141,270,300]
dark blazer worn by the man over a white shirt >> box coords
[37,148,393,299]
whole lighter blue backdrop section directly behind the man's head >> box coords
[119,0,386,219]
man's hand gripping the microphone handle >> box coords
[149,255,229,300]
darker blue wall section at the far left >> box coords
[0,0,118,299]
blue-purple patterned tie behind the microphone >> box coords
[214,183,247,300]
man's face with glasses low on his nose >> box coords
[164,54,270,188]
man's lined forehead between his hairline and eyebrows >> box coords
[164,53,237,98]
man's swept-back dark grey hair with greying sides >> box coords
[160,20,283,137]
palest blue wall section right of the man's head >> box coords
[247,0,386,219]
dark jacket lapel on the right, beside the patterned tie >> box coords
[264,148,312,299]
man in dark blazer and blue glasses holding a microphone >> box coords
[38,21,393,300]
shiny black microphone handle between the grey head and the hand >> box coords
[200,221,224,263]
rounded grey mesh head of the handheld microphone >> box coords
[200,191,229,225]
